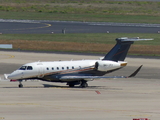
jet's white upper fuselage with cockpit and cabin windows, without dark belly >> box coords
[8,60,126,80]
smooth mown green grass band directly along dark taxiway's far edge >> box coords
[0,11,160,24]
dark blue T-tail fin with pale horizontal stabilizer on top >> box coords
[103,37,153,62]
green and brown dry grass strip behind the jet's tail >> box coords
[0,33,160,56]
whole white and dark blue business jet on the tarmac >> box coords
[4,37,153,88]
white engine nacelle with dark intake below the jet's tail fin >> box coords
[95,60,121,71]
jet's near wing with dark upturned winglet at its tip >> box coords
[59,65,142,80]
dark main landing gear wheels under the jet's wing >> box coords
[67,80,88,88]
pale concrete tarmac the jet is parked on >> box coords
[0,51,160,120]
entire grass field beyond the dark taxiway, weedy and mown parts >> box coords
[0,0,160,23]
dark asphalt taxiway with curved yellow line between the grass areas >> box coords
[0,19,160,34]
